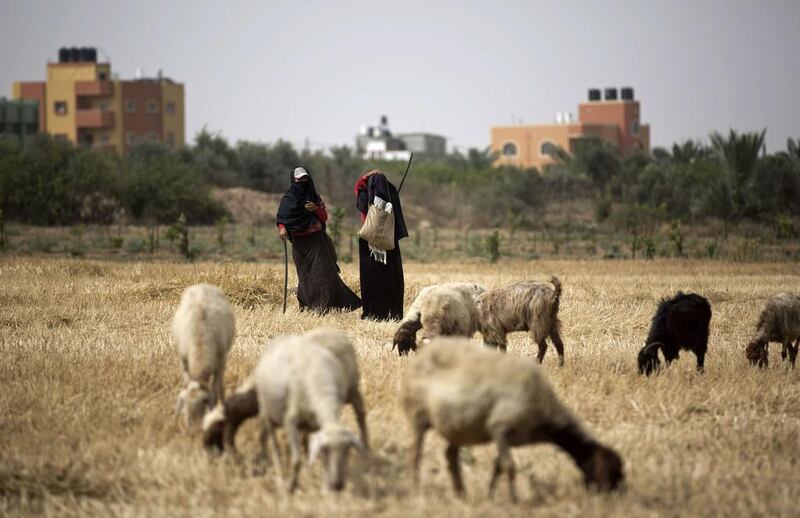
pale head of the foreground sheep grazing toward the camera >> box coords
[308,424,364,491]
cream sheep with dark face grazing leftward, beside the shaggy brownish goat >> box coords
[392,282,486,356]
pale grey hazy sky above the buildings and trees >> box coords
[0,0,800,150]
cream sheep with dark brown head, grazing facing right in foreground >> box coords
[402,337,624,500]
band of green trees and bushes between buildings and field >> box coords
[0,130,800,232]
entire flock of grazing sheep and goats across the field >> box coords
[172,277,800,499]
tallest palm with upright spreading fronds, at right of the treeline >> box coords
[709,129,767,218]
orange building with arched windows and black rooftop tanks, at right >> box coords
[492,88,650,169]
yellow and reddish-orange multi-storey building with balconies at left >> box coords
[13,47,185,153]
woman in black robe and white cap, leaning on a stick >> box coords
[277,167,361,313]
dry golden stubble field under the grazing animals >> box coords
[0,257,800,517]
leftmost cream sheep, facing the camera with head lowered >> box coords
[172,284,235,427]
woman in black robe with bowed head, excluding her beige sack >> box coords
[354,170,408,320]
